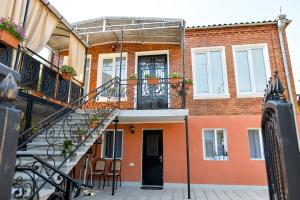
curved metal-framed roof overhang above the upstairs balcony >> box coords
[74,17,184,46]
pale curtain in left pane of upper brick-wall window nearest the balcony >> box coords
[195,53,209,94]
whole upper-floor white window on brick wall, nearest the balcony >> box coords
[192,47,229,99]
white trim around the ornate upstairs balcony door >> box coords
[134,50,171,108]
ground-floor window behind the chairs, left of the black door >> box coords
[102,130,123,159]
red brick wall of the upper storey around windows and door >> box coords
[64,25,295,116]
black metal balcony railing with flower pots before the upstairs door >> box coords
[120,78,185,110]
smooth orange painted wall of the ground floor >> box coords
[81,115,267,185]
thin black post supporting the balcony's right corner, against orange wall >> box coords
[184,116,191,199]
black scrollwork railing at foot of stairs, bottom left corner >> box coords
[12,155,84,199]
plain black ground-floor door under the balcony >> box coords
[142,130,163,186]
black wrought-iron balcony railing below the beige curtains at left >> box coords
[0,44,83,104]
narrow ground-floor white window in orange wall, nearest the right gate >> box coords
[248,129,264,160]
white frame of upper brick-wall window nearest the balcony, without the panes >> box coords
[191,46,230,99]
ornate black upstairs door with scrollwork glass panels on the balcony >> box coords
[137,55,168,109]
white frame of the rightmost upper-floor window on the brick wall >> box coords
[232,43,271,98]
